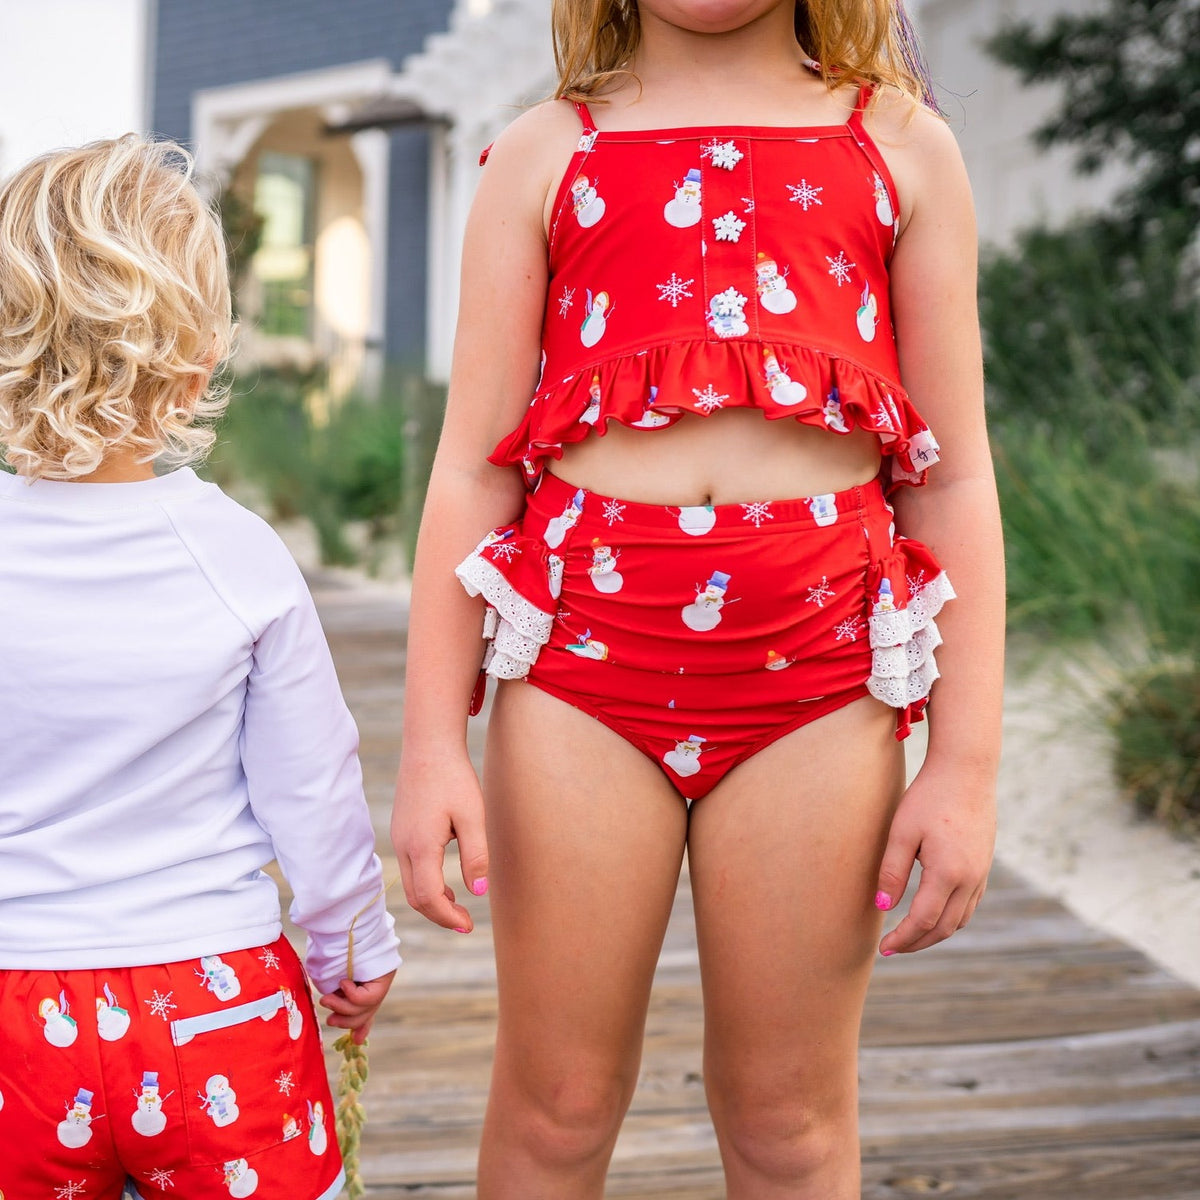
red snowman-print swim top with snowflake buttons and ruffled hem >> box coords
[488,88,937,486]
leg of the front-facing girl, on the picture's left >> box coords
[479,683,688,1200]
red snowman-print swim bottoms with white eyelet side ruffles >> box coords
[457,474,954,799]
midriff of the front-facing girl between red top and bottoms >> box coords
[551,408,880,504]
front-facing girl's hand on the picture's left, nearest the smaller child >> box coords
[391,755,487,934]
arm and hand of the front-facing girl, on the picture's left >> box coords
[392,104,568,932]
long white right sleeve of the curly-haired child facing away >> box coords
[241,552,400,998]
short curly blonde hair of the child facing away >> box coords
[0,133,234,479]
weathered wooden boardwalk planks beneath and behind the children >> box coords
[307,587,1200,1200]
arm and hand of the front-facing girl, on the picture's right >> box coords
[880,98,1003,954]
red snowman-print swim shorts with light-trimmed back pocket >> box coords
[0,937,343,1200]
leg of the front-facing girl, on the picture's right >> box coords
[688,698,904,1200]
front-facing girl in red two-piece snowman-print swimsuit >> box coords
[394,0,1003,1200]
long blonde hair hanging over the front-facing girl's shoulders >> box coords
[551,0,931,102]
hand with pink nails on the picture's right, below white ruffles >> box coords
[875,762,996,958]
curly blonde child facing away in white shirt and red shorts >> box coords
[0,136,400,1200]
